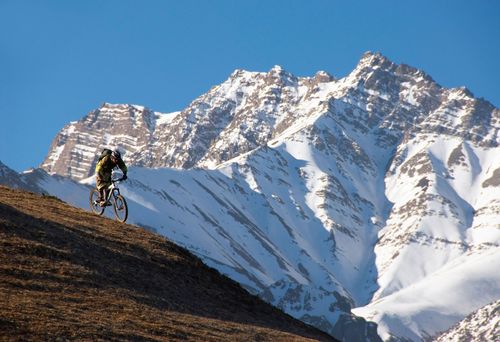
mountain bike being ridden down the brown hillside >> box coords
[90,178,128,222]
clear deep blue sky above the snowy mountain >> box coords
[0,0,500,171]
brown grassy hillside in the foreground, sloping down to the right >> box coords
[0,186,333,341]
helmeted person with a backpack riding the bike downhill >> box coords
[95,150,128,206]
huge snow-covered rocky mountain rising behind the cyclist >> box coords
[4,53,500,341]
